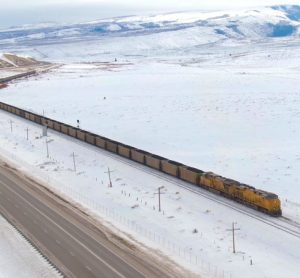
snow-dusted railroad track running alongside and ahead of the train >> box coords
[86,142,300,238]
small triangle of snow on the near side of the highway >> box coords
[0,215,60,278]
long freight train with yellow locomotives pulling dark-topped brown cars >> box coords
[0,102,281,216]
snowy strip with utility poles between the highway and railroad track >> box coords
[0,111,300,278]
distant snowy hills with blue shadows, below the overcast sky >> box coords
[0,6,300,62]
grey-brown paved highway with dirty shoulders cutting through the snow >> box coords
[0,161,183,278]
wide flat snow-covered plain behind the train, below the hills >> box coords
[0,57,300,205]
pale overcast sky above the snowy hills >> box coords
[0,0,300,28]
